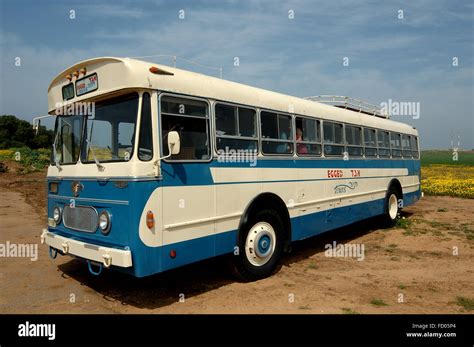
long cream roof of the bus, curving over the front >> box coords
[48,57,418,135]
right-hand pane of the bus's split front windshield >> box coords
[81,93,138,164]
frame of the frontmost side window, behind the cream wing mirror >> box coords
[157,92,213,164]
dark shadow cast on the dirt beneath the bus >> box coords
[58,212,411,313]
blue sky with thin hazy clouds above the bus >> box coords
[0,0,474,149]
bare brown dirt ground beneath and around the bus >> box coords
[0,166,474,313]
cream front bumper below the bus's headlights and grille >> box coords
[41,229,132,268]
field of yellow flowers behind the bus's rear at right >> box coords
[421,164,474,199]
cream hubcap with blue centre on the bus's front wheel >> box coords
[245,222,276,266]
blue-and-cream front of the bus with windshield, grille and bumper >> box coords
[47,91,160,276]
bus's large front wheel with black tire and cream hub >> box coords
[231,209,284,282]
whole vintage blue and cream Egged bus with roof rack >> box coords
[41,57,421,281]
